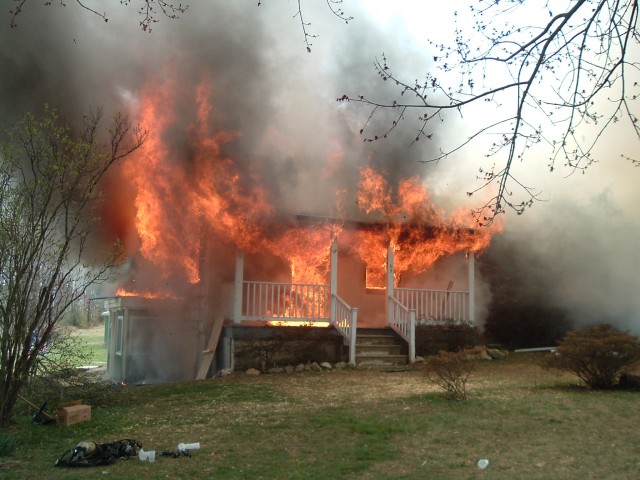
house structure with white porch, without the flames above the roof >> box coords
[105,216,490,383]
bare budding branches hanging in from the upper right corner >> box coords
[338,0,640,224]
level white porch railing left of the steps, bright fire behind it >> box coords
[242,281,331,322]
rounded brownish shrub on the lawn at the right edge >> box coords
[545,324,640,389]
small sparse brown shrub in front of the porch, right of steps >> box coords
[425,349,478,400]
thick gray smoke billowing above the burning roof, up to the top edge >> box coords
[0,2,438,215]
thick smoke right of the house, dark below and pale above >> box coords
[483,167,640,343]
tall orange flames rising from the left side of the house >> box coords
[126,76,338,284]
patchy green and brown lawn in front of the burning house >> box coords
[0,355,640,480]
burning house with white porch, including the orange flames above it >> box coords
[100,77,500,383]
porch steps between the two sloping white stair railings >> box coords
[356,328,409,366]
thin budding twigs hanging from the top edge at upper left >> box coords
[9,0,189,32]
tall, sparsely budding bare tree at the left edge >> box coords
[0,108,146,426]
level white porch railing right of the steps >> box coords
[393,288,471,323]
